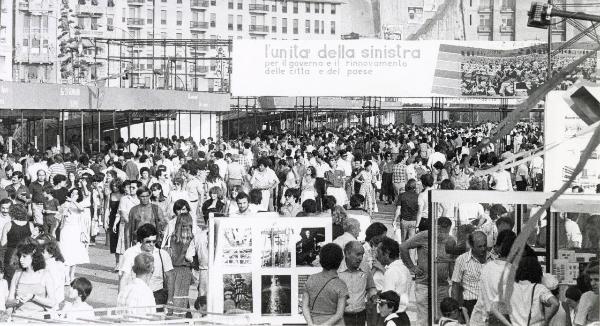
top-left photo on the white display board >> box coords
[223,227,252,266]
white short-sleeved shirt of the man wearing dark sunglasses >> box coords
[119,243,173,291]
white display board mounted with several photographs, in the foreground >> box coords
[207,214,332,324]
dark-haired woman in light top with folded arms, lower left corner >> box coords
[6,243,56,315]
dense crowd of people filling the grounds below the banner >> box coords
[0,123,598,326]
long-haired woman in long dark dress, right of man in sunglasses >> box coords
[163,201,196,316]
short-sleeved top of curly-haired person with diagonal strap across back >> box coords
[305,272,348,324]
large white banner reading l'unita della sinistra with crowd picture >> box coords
[231,39,596,98]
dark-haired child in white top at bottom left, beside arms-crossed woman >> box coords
[60,277,95,319]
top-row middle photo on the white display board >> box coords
[260,228,294,268]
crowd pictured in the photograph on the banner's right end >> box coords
[461,52,596,97]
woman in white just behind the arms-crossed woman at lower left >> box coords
[41,240,69,304]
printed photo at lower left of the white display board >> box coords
[223,273,252,314]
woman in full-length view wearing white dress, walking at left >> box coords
[60,188,90,280]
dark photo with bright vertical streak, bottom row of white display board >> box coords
[260,275,292,315]
